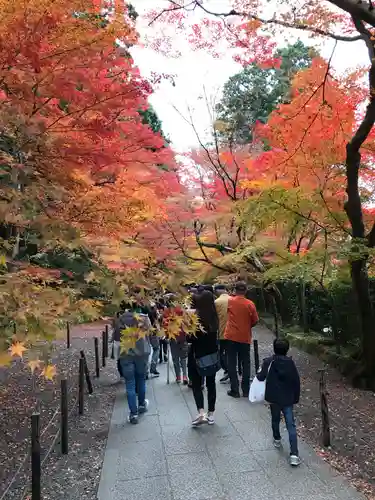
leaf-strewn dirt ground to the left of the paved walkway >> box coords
[0,323,118,500]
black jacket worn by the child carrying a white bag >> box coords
[257,355,301,408]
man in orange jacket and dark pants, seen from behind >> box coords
[224,282,259,398]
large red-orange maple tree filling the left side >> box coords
[0,0,178,374]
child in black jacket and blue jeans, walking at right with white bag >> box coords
[257,339,301,466]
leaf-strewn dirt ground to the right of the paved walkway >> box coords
[257,327,375,500]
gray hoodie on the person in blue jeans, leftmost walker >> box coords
[113,311,151,358]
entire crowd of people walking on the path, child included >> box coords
[113,282,300,465]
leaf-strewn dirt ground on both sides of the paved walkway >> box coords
[0,323,375,500]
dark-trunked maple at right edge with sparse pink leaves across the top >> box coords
[149,0,375,385]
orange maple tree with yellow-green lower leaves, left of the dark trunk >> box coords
[242,58,362,276]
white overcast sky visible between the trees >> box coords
[132,0,368,152]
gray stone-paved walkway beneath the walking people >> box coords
[98,331,364,500]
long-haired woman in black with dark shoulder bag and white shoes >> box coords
[189,290,219,427]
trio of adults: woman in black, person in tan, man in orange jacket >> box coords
[189,282,258,426]
